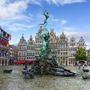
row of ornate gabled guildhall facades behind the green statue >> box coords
[18,26,86,65]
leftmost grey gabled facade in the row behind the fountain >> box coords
[18,34,27,60]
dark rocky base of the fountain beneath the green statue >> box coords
[30,56,75,76]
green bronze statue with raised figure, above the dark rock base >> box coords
[38,9,50,58]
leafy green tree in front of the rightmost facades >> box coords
[74,47,88,61]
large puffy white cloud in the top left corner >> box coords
[0,0,27,19]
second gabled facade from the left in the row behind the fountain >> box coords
[26,35,35,60]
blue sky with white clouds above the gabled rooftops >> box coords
[0,0,90,48]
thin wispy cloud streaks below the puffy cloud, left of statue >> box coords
[0,15,35,31]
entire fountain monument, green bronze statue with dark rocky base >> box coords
[22,9,75,76]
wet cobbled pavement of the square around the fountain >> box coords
[0,65,90,90]
